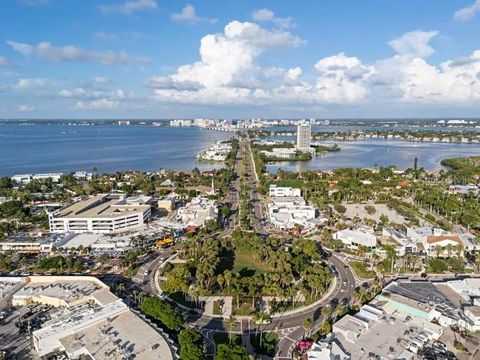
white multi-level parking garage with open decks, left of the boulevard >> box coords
[48,194,151,233]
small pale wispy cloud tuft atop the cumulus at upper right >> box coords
[388,30,438,58]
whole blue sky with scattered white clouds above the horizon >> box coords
[0,0,480,119]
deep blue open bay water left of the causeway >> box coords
[0,124,232,176]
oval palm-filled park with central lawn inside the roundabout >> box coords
[160,231,332,315]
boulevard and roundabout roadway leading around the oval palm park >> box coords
[140,137,357,359]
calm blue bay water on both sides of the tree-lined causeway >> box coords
[0,124,480,176]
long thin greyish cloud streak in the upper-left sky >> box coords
[7,41,148,65]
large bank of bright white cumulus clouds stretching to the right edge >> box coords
[146,25,480,107]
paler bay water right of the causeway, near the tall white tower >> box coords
[267,140,480,172]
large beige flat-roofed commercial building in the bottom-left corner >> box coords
[0,276,176,360]
